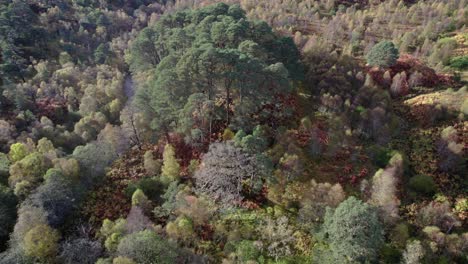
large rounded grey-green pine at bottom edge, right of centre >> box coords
[323,196,384,263]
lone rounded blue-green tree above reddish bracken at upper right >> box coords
[366,41,399,68]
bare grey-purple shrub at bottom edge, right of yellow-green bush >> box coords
[60,238,102,264]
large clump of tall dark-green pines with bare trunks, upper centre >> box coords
[131,3,301,134]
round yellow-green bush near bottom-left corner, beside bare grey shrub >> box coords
[23,225,60,262]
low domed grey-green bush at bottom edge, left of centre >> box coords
[117,230,178,264]
